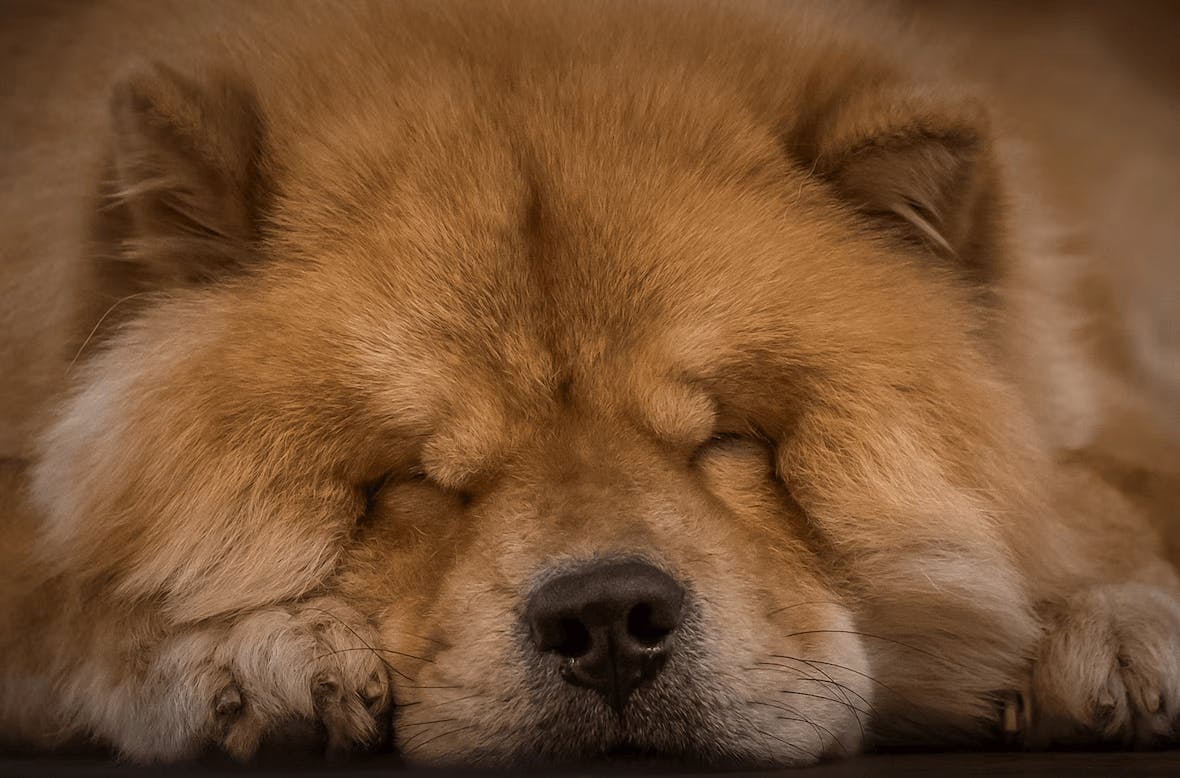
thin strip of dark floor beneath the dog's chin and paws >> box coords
[0,751,1180,778]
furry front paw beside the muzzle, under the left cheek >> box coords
[111,599,391,761]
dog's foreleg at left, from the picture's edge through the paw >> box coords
[0,571,391,763]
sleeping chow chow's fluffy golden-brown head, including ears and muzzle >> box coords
[37,6,1031,764]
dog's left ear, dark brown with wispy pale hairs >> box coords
[107,64,263,287]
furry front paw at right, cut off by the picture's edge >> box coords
[1030,583,1180,747]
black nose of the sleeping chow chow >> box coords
[525,560,684,713]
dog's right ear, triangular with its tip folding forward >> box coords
[797,89,999,276]
